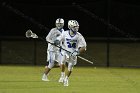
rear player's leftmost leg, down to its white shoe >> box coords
[42,52,55,81]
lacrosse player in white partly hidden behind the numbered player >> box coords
[42,18,65,81]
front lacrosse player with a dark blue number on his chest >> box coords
[57,20,87,86]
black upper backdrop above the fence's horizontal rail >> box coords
[0,0,140,38]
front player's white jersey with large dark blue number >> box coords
[57,30,86,54]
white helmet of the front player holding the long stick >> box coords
[68,20,79,32]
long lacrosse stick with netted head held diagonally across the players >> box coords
[25,30,93,64]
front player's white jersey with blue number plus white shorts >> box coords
[57,30,86,65]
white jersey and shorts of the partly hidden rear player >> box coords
[46,28,64,62]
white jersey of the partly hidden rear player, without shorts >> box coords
[46,28,64,52]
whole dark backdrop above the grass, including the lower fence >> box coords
[0,0,140,67]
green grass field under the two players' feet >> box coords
[0,66,140,93]
